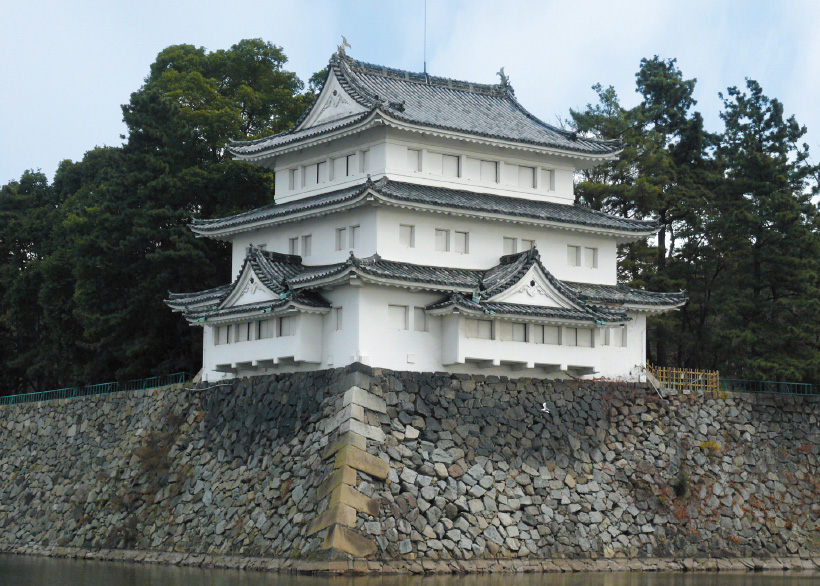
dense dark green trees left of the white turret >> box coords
[0,39,313,393]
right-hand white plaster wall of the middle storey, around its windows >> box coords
[376,208,618,285]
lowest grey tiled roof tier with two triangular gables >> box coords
[166,247,686,322]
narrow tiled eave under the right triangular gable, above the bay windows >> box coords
[425,293,629,323]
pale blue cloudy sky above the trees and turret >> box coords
[0,0,820,185]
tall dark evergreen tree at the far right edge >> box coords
[712,80,820,382]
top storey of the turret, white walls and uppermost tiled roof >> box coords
[229,54,620,204]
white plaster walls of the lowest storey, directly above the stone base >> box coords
[203,285,646,381]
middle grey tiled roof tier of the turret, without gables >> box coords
[191,178,657,235]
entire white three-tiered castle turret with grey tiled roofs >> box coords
[167,55,686,380]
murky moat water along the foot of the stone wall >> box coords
[0,555,820,586]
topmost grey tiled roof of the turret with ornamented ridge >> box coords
[230,55,621,155]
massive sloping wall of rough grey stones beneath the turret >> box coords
[0,365,820,572]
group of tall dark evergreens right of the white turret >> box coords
[570,56,820,382]
